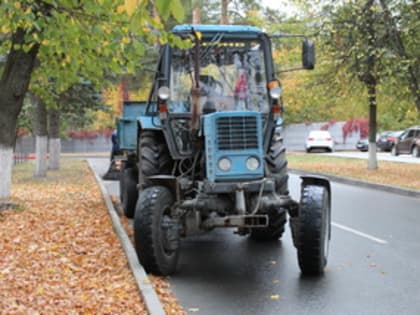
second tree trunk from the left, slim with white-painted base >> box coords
[32,96,48,177]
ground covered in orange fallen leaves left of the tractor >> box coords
[0,160,182,314]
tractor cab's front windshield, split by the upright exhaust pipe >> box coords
[169,40,269,113]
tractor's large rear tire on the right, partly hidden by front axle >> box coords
[250,137,289,241]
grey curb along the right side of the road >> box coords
[289,168,420,198]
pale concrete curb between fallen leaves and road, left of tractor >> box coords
[88,160,166,315]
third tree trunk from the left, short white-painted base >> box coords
[48,109,61,170]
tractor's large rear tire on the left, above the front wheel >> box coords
[138,130,173,190]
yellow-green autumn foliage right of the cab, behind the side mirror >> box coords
[274,0,420,130]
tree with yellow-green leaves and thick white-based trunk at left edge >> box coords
[0,0,183,199]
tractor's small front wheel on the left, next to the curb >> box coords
[134,186,180,276]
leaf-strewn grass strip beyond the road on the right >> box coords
[287,153,420,190]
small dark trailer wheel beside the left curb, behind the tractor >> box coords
[120,168,138,218]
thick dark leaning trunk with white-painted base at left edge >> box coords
[0,28,39,199]
